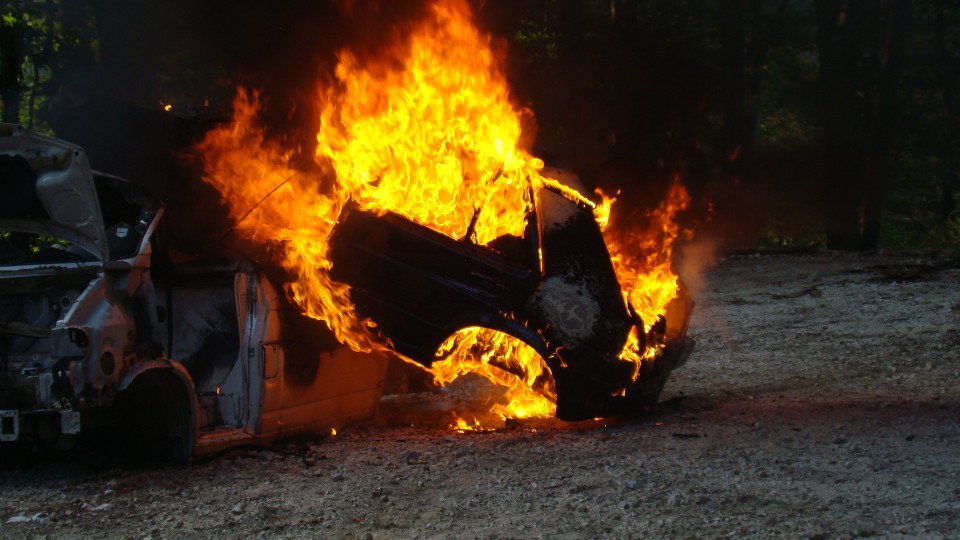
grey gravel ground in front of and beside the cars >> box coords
[0,253,960,538]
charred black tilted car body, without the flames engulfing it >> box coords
[331,169,694,420]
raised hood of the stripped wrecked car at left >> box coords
[0,124,107,262]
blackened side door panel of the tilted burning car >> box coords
[331,202,539,363]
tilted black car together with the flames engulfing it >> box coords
[194,0,692,426]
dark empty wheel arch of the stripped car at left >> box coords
[114,369,197,465]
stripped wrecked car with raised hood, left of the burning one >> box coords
[0,124,387,461]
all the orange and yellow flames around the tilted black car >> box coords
[198,0,689,429]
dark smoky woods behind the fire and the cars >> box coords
[0,0,960,251]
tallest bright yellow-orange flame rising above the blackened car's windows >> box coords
[317,0,543,244]
